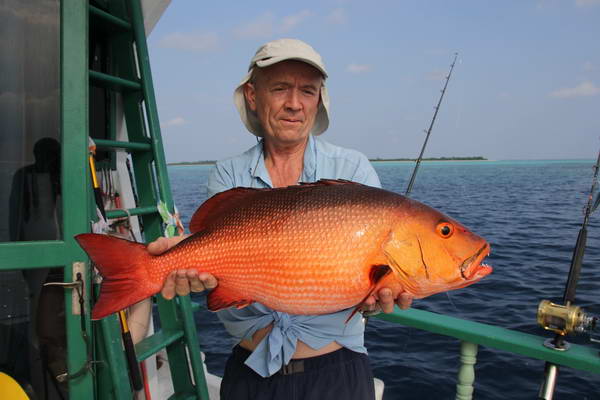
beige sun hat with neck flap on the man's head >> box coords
[233,39,329,137]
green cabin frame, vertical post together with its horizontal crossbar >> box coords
[0,0,94,399]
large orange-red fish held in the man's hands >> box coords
[76,180,491,319]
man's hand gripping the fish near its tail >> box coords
[147,235,218,300]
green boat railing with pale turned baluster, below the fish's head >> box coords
[374,308,600,400]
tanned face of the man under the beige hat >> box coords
[244,61,322,145]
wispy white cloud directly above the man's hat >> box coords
[233,10,312,39]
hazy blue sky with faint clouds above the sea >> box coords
[148,0,600,162]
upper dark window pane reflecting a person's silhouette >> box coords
[0,0,62,242]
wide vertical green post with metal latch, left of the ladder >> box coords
[60,0,94,399]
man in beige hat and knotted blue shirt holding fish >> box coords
[148,39,412,400]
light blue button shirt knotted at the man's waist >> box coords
[208,136,381,377]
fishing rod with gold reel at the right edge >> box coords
[537,148,600,400]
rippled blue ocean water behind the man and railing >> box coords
[169,160,600,400]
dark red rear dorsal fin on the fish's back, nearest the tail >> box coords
[190,187,264,233]
